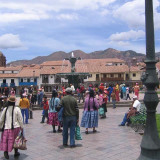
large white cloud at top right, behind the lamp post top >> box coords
[113,0,160,28]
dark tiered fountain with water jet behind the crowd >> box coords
[56,52,90,88]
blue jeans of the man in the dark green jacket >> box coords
[63,116,77,146]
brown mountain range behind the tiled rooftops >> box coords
[7,48,160,66]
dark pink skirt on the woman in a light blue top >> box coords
[48,112,61,126]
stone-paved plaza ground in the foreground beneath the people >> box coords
[0,93,160,160]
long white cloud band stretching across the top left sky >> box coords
[0,0,116,23]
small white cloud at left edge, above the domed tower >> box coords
[0,34,23,49]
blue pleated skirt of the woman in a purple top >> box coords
[81,111,98,128]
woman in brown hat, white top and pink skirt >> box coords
[0,96,23,159]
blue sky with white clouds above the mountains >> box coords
[0,0,160,63]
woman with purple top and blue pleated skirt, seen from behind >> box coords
[81,90,99,134]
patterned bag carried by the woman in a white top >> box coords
[13,131,27,150]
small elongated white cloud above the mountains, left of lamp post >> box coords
[109,30,145,41]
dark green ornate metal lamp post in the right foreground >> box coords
[138,0,160,160]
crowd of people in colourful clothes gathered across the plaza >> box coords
[0,83,140,159]
